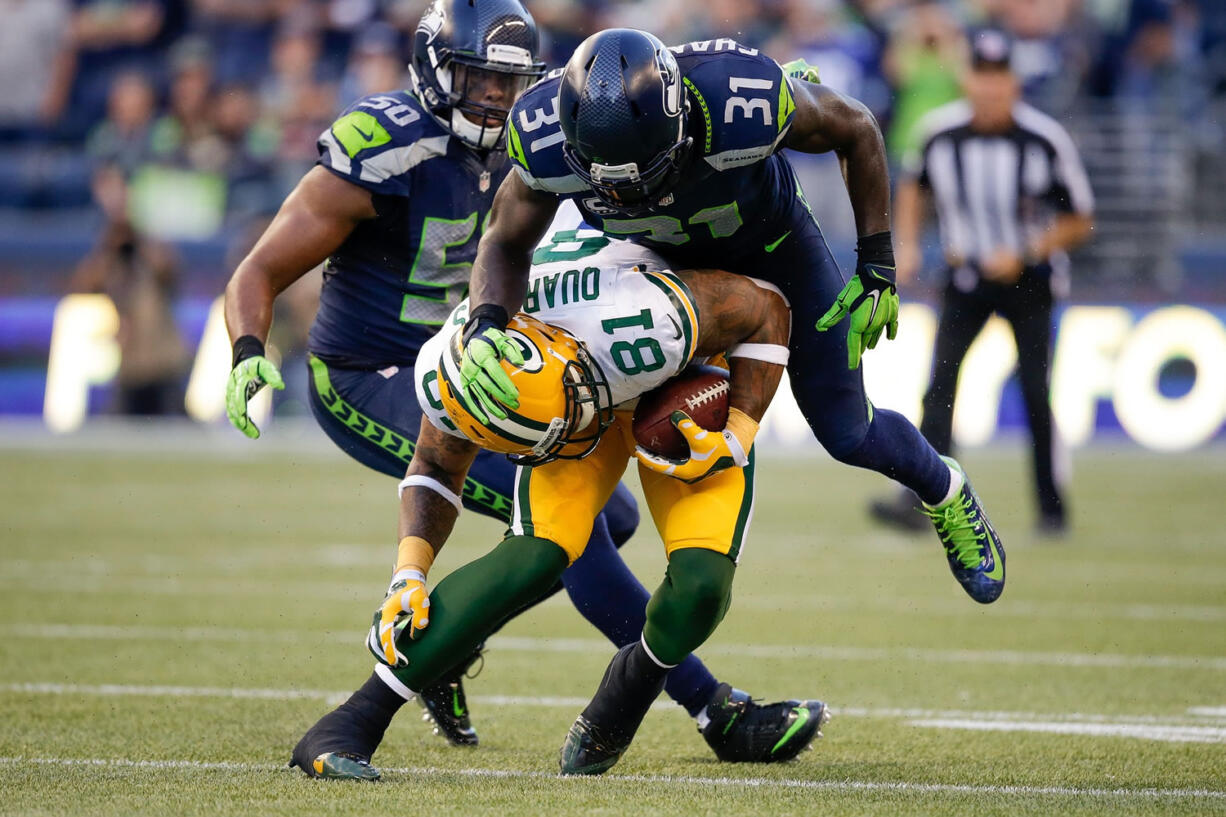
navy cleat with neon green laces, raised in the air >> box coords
[924,456,1004,605]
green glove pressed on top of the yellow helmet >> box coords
[460,304,524,423]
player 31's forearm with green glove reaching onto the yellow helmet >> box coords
[460,173,558,420]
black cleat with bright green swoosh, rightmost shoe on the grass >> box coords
[699,683,830,763]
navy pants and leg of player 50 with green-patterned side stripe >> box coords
[308,356,718,715]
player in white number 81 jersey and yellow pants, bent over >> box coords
[295,220,826,774]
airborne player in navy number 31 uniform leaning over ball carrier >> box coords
[463,28,1004,604]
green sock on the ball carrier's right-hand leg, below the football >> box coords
[642,547,737,664]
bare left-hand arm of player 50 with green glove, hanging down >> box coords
[226,167,375,431]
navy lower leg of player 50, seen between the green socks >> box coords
[562,515,720,715]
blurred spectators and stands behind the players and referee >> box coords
[0,0,1226,413]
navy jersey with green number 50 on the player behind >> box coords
[309,91,509,368]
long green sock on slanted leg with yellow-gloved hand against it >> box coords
[394,536,566,692]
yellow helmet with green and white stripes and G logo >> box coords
[439,313,613,465]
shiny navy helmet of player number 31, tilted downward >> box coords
[558,28,693,213]
